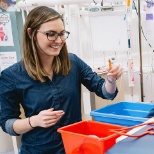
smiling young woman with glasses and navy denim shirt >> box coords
[0,6,122,154]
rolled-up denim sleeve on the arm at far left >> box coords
[0,69,21,136]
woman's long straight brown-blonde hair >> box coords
[22,6,70,82]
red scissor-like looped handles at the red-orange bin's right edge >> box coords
[110,122,154,138]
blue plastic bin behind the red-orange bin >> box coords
[90,102,154,126]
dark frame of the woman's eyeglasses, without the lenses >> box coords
[37,30,70,41]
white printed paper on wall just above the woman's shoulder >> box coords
[0,51,17,73]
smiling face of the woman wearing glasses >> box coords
[36,19,65,58]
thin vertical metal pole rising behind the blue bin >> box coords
[138,0,144,102]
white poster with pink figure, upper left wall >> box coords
[0,13,14,46]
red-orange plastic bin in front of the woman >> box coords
[58,120,126,154]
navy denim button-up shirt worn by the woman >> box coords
[0,53,118,154]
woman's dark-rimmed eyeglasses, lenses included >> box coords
[37,30,70,41]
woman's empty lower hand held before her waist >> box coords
[30,108,65,128]
